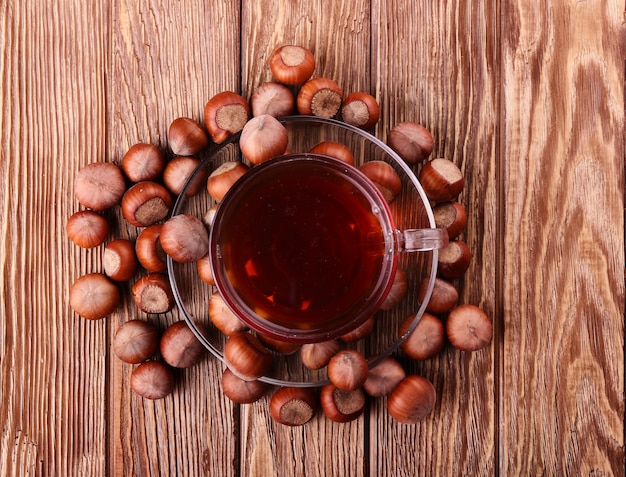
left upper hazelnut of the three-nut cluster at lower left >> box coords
[113,320,159,364]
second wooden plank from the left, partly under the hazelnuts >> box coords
[107,0,240,476]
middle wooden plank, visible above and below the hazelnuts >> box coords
[241,0,373,477]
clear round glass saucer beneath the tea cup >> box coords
[167,116,438,387]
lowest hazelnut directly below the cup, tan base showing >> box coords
[270,387,319,426]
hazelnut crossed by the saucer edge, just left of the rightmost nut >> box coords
[399,313,446,361]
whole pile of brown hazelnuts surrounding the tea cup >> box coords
[66,45,492,425]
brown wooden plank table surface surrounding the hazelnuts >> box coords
[0,0,626,477]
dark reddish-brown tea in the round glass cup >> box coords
[211,156,393,340]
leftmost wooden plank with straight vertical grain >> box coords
[0,1,108,476]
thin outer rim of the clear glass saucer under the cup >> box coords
[166,115,439,387]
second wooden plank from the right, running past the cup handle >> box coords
[369,0,502,476]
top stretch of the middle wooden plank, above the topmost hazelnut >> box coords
[242,0,371,96]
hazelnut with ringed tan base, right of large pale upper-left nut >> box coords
[122,181,172,227]
